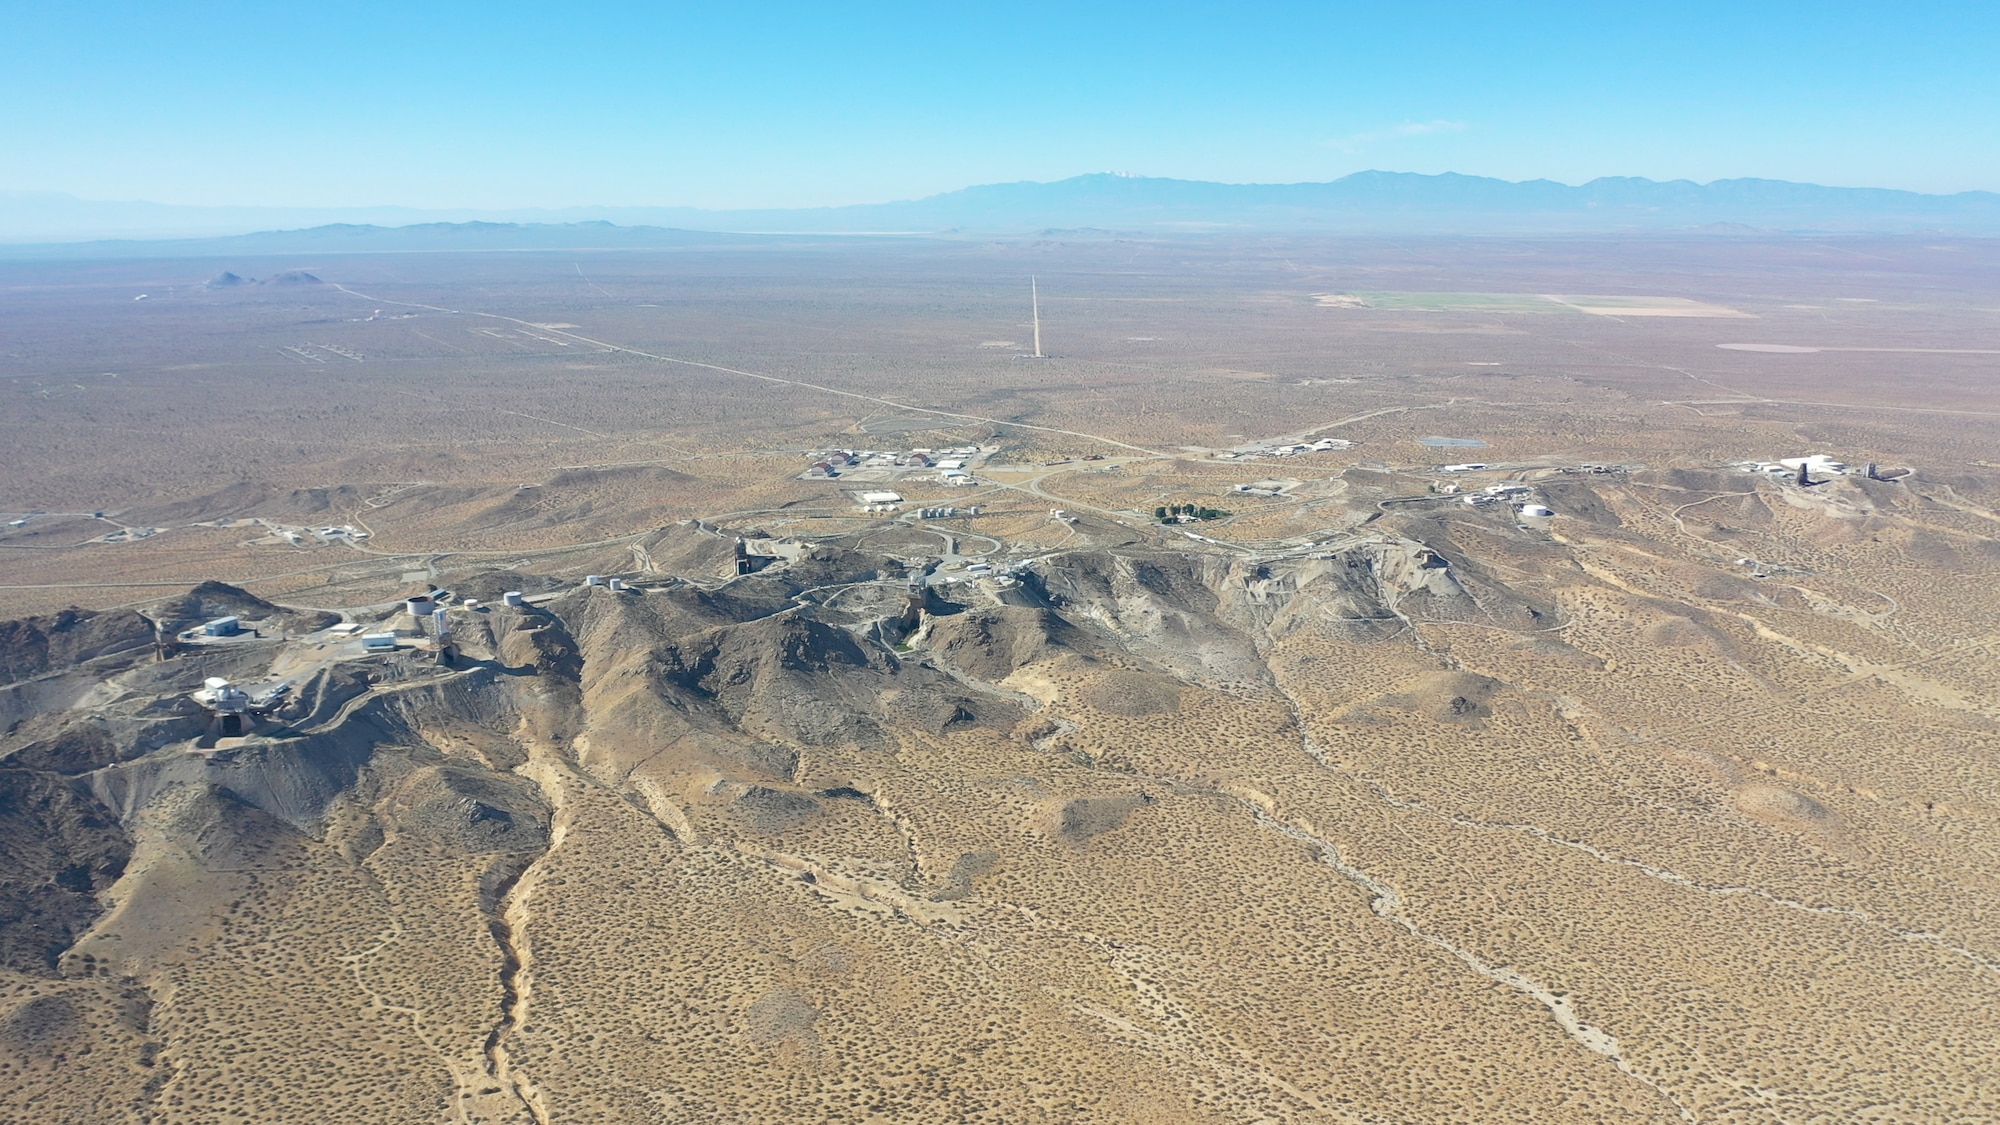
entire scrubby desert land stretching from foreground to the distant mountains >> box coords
[0,232,2000,1125]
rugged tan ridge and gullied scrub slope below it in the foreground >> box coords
[0,472,2000,1123]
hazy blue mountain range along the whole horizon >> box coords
[0,172,2000,254]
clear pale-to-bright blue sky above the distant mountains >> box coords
[0,0,2000,208]
